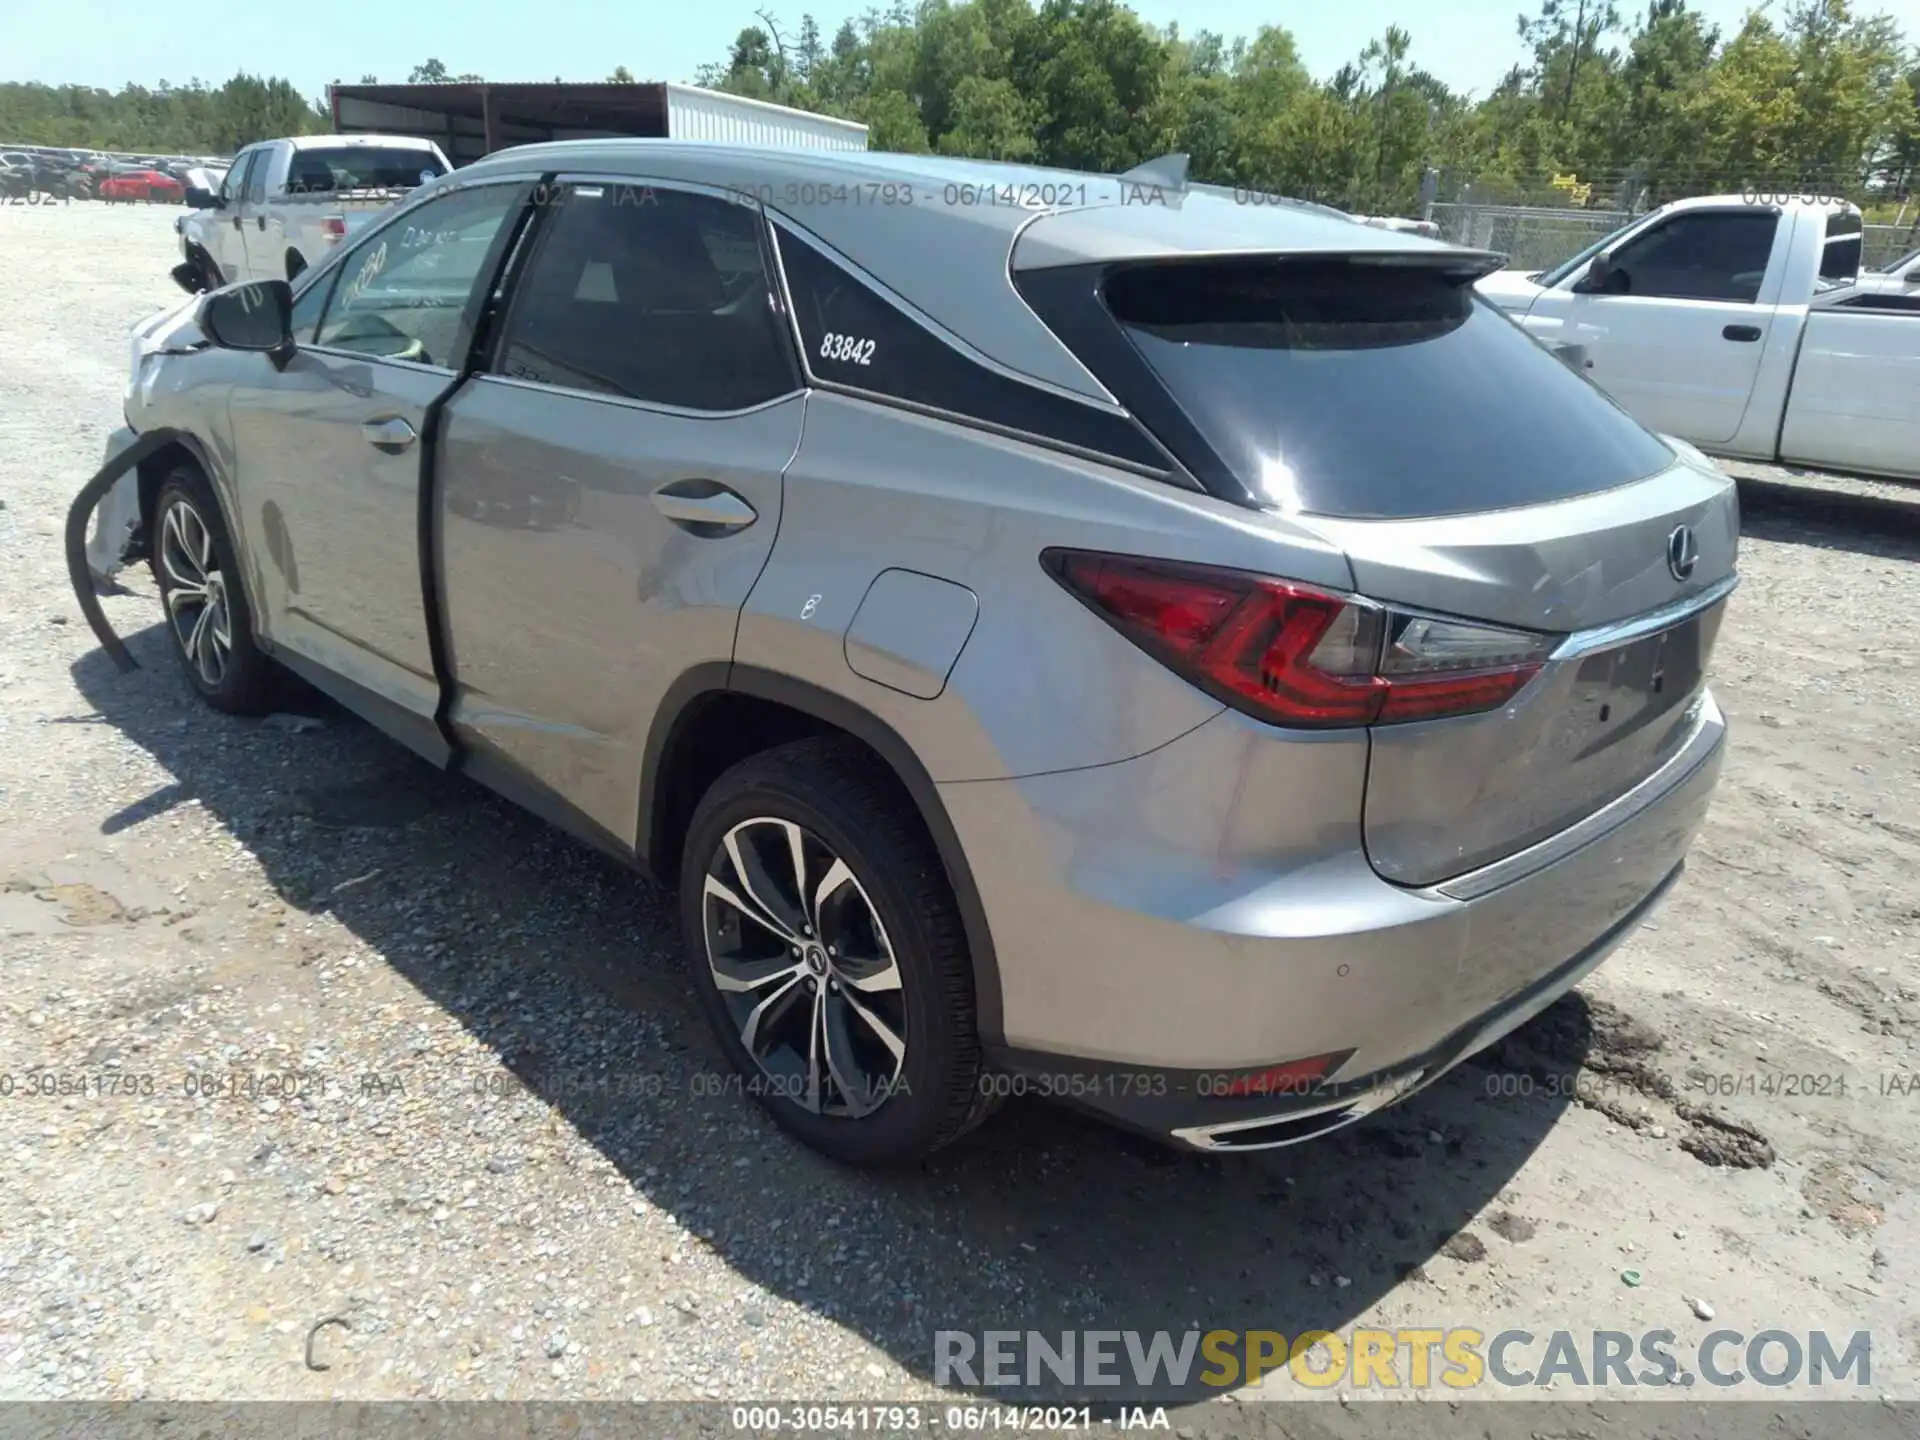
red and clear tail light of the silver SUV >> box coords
[1041,549,1559,730]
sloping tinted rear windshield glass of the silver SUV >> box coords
[1106,259,1672,518]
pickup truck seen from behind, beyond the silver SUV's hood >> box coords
[173,134,451,292]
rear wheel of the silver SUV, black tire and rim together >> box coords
[680,739,989,1165]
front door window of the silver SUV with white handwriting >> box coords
[313,184,524,367]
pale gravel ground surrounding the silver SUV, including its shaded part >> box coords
[0,205,1920,1415]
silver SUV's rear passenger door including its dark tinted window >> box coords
[438,177,806,843]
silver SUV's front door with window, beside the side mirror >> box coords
[230,182,526,758]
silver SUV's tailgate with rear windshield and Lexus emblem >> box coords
[1052,255,1738,898]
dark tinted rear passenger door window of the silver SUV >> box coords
[493,184,797,413]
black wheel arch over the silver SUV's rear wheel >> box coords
[636,660,1004,1046]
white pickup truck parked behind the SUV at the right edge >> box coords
[1478,196,1920,487]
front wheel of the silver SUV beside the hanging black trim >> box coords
[152,465,286,714]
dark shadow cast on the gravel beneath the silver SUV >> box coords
[73,624,1596,1404]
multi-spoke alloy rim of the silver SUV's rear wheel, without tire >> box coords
[701,816,906,1119]
